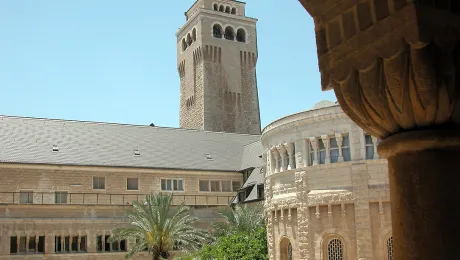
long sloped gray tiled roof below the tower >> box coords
[0,116,260,171]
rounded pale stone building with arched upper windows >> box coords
[261,101,393,260]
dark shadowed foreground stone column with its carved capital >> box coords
[300,0,460,260]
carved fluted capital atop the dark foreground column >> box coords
[300,0,460,138]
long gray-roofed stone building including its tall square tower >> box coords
[0,0,264,260]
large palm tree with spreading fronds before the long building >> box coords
[109,194,208,260]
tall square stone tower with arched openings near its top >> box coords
[176,0,260,134]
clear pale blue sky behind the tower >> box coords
[0,0,336,127]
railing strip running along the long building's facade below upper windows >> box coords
[0,192,235,206]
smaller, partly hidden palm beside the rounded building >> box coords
[213,203,265,237]
